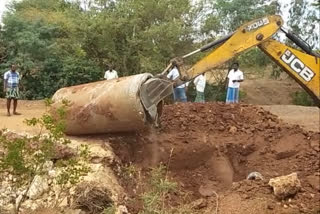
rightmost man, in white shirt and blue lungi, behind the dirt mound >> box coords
[226,62,244,103]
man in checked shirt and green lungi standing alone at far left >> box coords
[3,64,20,116]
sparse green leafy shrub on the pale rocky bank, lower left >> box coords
[0,101,90,213]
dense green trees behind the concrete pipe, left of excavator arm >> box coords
[2,0,202,99]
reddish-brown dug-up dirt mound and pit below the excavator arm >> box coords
[109,103,320,213]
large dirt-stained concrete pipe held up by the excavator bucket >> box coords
[52,74,160,135]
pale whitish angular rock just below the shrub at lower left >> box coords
[27,175,49,199]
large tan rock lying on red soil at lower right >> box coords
[269,173,301,199]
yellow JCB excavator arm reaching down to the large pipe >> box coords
[141,15,320,111]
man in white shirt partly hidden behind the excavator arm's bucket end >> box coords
[167,61,187,102]
